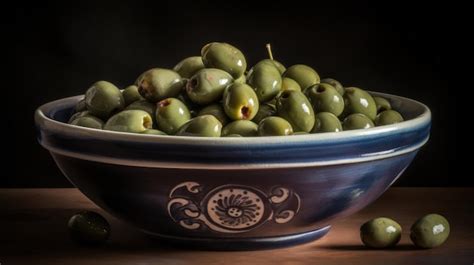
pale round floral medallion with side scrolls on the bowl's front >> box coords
[168,182,300,233]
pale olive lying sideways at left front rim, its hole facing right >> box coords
[104,110,153,133]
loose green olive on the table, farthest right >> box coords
[410,214,451,248]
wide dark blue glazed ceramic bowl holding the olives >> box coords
[35,93,431,250]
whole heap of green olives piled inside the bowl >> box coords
[69,42,403,137]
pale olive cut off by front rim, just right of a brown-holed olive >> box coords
[176,115,222,137]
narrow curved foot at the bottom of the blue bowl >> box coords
[145,226,331,251]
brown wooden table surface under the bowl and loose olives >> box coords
[0,188,474,265]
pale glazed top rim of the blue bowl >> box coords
[35,91,431,145]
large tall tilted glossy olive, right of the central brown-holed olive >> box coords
[276,90,314,132]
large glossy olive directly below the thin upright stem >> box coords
[247,62,281,102]
